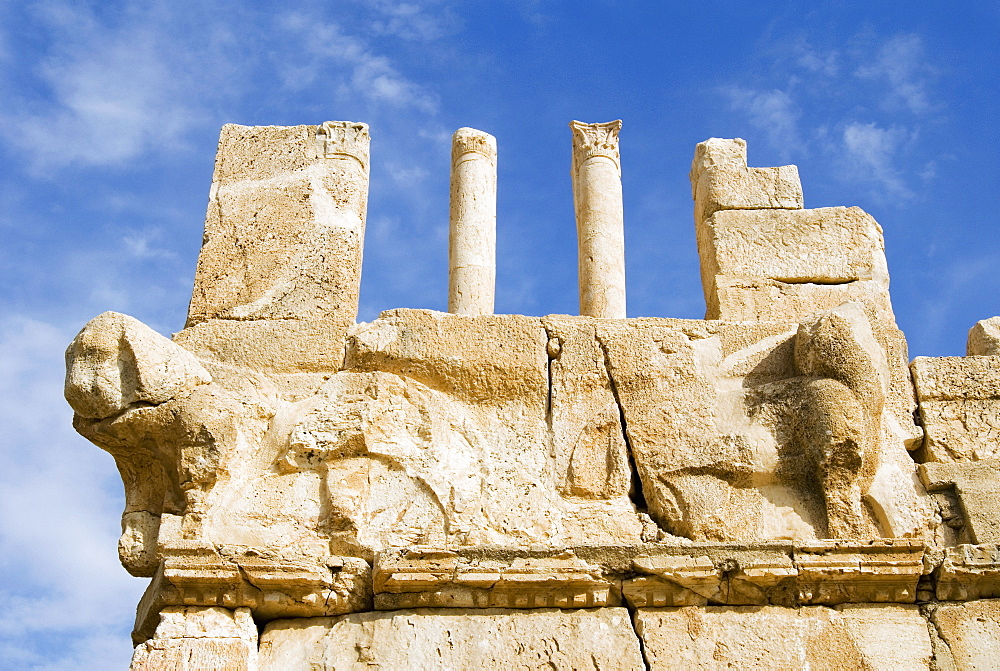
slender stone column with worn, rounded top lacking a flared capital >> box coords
[448,128,497,315]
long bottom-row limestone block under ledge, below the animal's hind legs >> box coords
[635,604,931,669]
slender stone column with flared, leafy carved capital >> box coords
[569,119,625,319]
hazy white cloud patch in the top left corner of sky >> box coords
[2,3,213,171]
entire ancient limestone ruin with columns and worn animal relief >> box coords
[66,121,1000,669]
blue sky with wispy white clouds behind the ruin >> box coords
[0,0,1000,669]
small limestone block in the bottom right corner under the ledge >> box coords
[931,599,1000,669]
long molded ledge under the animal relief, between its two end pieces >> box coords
[373,539,925,610]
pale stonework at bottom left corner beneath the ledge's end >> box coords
[130,606,258,671]
